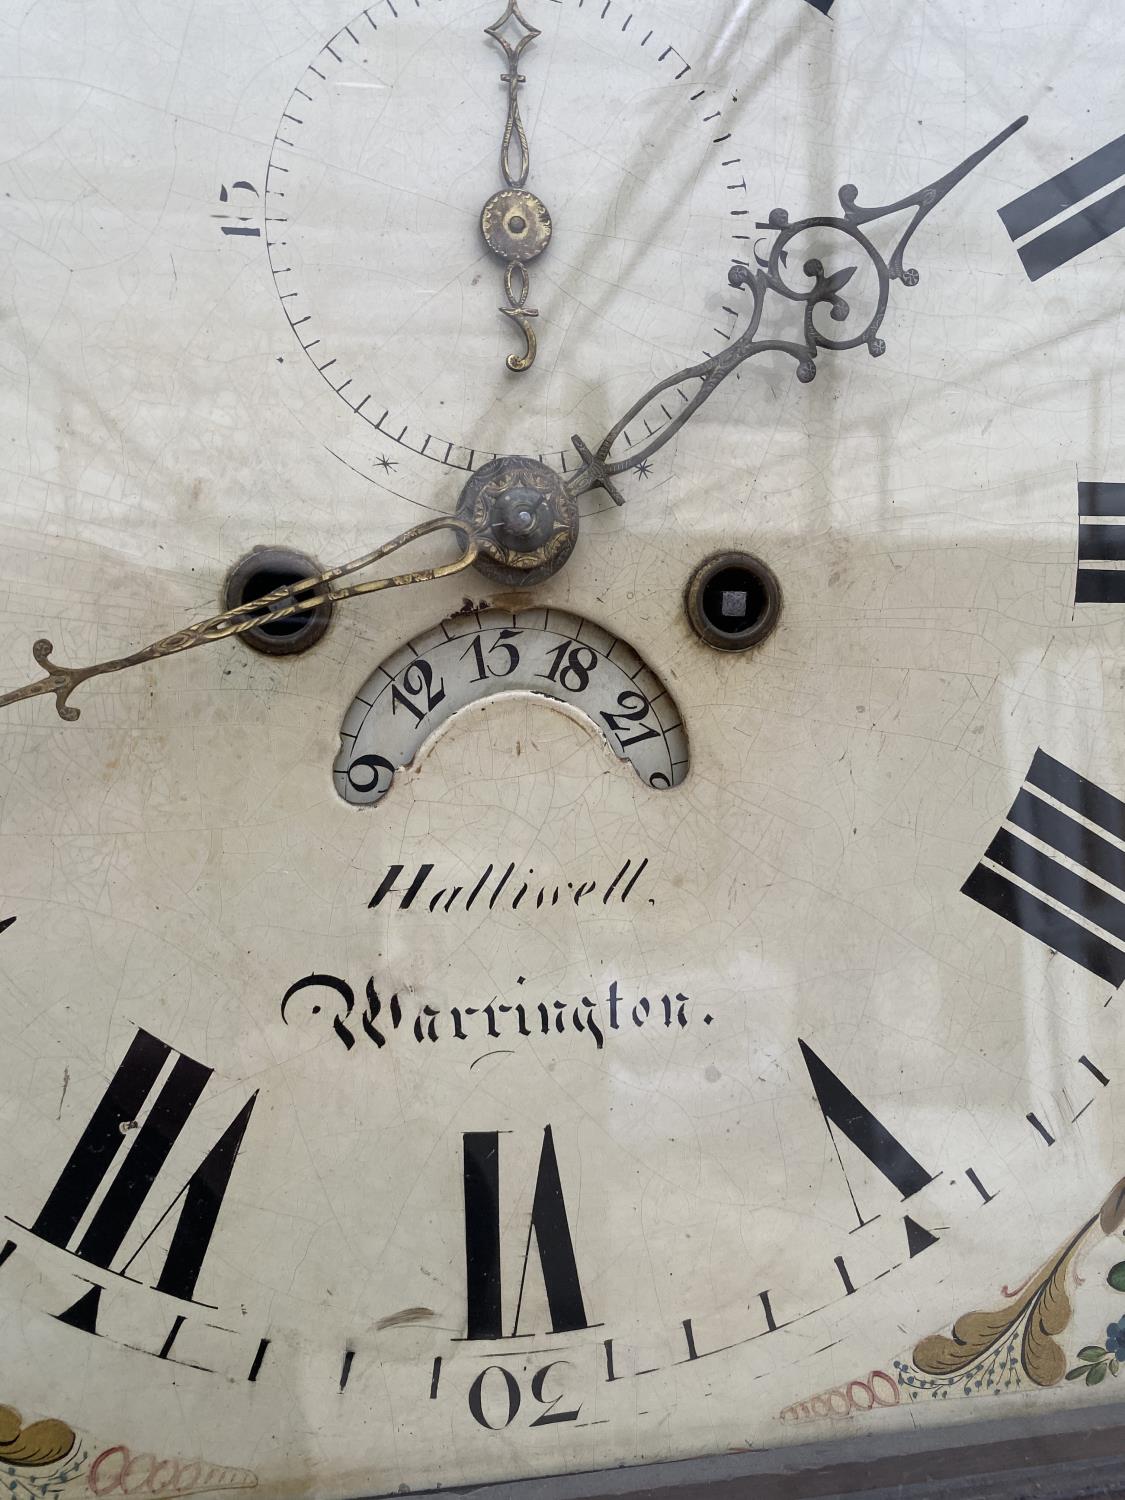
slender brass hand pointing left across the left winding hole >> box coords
[0,516,480,723]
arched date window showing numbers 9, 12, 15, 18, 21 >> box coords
[333,606,689,806]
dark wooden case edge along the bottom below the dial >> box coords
[363,1398,1125,1500]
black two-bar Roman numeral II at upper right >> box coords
[999,135,1125,281]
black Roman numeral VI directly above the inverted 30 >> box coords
[465,1125,590,1338]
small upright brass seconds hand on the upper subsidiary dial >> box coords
[480,0,552,374]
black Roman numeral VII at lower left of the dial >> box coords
[32,1031,258,1301]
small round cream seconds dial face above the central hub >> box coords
[266,0,753,470]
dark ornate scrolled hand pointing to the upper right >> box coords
[564,116,1028,506]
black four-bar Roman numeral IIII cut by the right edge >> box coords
[962,750,1125,987]
